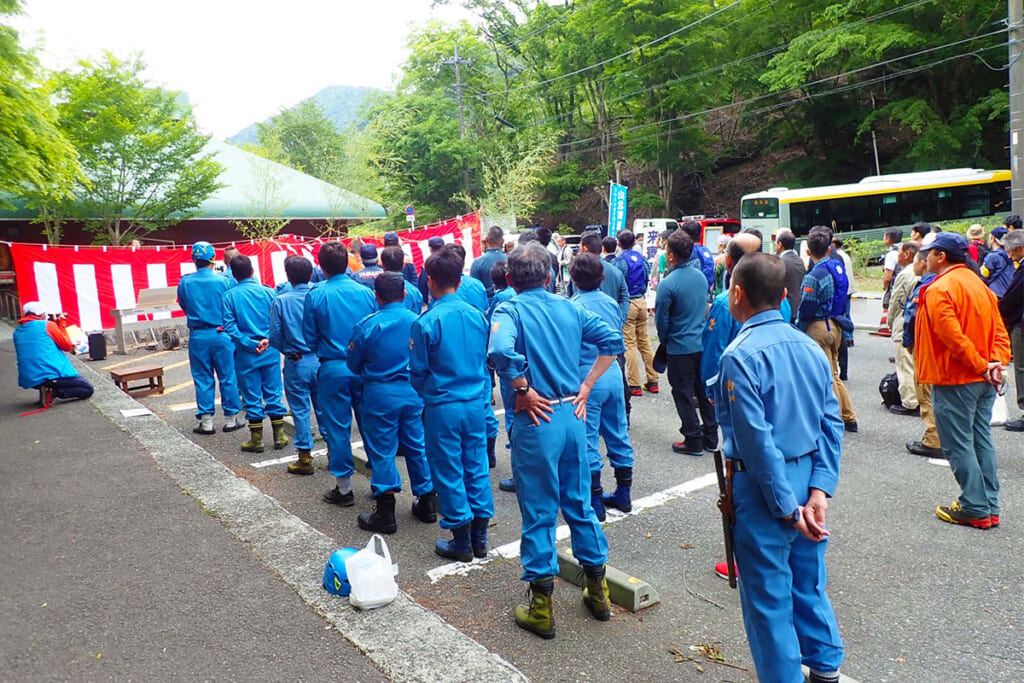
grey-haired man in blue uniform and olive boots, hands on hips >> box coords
[487,244,624,638]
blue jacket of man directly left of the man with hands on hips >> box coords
[409,290,490,405]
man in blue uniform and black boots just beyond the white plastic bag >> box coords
[348,272,437,533]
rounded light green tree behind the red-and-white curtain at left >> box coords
[54,54,223,244]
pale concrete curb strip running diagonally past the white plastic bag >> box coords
[72,358,527,682]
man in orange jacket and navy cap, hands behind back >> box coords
[914,232,1010,528]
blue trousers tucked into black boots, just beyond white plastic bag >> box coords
[359,381,434,496]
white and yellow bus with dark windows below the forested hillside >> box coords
[739,168,1010,242]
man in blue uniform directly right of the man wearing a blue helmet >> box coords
[224,256,288,453]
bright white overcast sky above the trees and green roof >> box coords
[12,0,472,138]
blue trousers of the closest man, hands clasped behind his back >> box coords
[732,456,843,683]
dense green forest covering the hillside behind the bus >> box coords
[301,0,1009,227]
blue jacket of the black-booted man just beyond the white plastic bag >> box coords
[348,302,416,382]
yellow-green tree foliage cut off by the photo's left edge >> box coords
[0,0,81,207]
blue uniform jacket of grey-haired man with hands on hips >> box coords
[487,287,626,398]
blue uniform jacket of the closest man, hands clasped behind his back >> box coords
[715,310,843,517]
